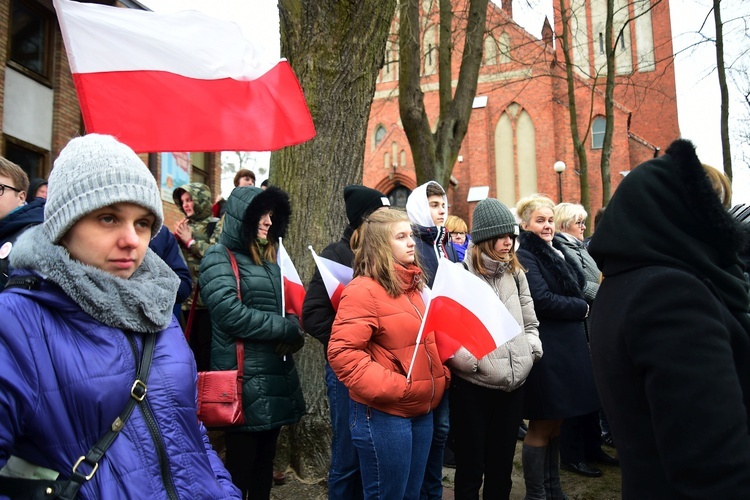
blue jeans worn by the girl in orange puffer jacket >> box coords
[349,400,432,500]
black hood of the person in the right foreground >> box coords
[589,139,750,311]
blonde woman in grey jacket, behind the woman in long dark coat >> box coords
[554,203,619,477]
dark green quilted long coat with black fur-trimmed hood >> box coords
[199,187,305,432]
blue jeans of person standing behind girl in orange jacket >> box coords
[326,363,362,500]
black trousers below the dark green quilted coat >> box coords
[225,428,281,500]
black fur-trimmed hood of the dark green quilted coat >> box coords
[219,186,292,253]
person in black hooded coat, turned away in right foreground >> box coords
[592,140,750,499]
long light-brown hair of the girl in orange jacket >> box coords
[349,208,424,297]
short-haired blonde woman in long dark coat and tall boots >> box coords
[516,195,599,500]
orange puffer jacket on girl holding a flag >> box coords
[328,267,450,417]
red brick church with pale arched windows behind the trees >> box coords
[363,0,679,222]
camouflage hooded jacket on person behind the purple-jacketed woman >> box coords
[172,182,222,311]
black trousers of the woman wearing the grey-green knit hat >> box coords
[450,376,523,500]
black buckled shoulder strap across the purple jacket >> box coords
[53,332,156,500]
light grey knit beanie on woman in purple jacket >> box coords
[42,134,164,243]
